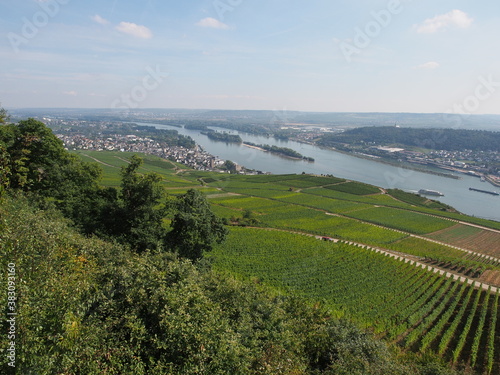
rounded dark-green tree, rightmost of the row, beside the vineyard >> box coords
[168,189,228,261]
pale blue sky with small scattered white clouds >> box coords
[0,0,500,114]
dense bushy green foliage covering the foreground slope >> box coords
[0,198,432,375]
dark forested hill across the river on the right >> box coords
[318,126,500,151]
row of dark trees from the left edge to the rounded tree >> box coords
[0,119,227,260]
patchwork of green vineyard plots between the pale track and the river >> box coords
[79,151,500,269]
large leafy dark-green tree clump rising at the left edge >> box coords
[0,119,108,228]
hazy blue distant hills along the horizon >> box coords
[11,108,500,133]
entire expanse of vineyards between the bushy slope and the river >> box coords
[74,152,500,374]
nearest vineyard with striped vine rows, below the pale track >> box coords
[211,228,500,374]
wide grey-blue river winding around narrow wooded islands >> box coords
[138,123,500,221]
